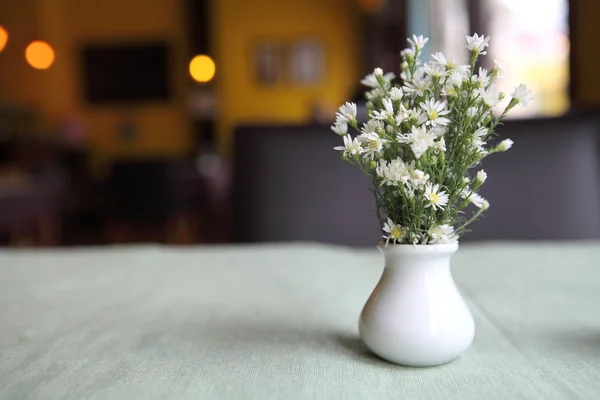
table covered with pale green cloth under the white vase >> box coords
[0,242,600,399]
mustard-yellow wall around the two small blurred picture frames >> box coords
[213,0,360,153]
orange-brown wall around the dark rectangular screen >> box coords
[0,0,191,156]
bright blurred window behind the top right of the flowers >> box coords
[426,0,569,117]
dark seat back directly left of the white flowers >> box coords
[233,126,381,246]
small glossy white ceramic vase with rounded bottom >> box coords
[359,243,475,367]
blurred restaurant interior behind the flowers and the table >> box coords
[0,0,600,246]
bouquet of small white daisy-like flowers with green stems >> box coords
[331,34,532,245]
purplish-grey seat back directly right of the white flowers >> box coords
[464,117,600,241]
